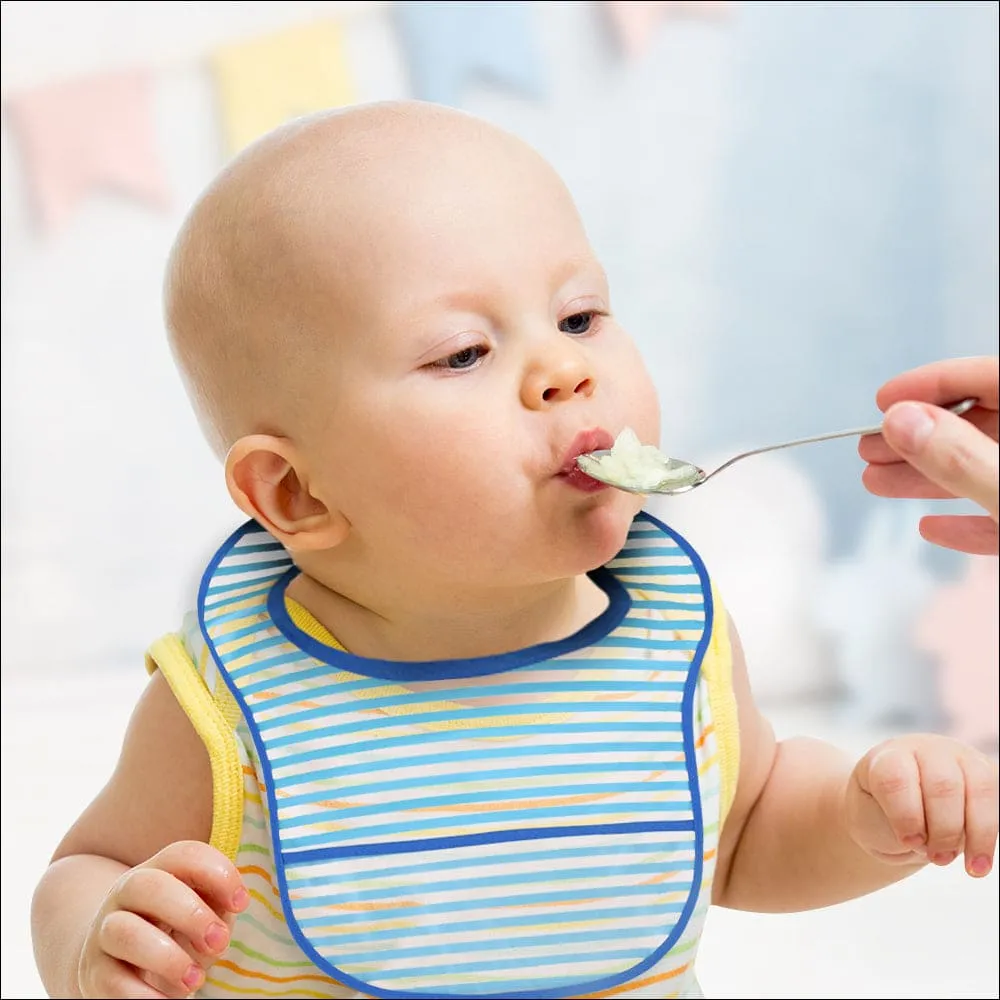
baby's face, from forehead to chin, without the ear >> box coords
[295,123,659,587]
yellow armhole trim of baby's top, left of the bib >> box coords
[146,635,243,861]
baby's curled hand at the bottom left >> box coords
[79,840,250,998]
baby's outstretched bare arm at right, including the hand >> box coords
[713,622,997,913]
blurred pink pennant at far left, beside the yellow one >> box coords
[8,70,169,231]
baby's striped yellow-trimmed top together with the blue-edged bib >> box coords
[148,514,738,1000]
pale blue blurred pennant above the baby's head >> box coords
[395,3,545,106]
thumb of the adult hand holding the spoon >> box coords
[882,402,998,521]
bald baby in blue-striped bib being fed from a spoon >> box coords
[27,103,997,998]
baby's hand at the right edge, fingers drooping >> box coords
[845,735,997,876]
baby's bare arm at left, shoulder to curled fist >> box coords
[32,672,247,997]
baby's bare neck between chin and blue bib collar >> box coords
[288,572,608,661]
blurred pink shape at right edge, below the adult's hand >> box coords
[916,556,1000,745]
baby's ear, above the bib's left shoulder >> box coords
[226,434,350,551]
